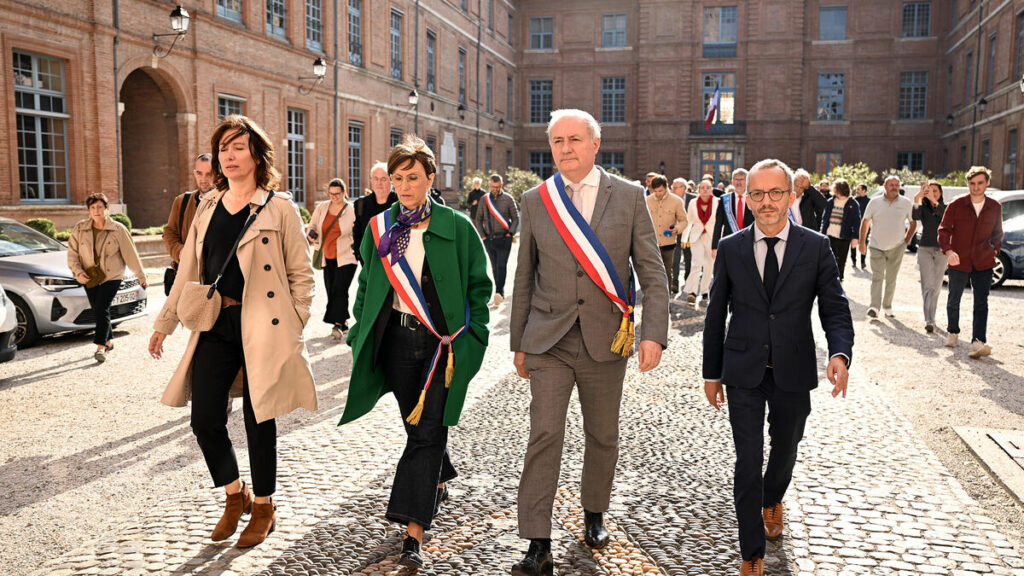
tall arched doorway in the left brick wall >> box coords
[120,68,187,228]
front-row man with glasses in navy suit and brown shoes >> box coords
[703,160,853,575]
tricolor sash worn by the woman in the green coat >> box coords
[370,210,469,426]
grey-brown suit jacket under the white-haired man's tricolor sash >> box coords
[509,165,669,362]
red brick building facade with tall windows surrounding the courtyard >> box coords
[0,0,1024,228]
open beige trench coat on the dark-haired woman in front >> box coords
[154,191,316,422]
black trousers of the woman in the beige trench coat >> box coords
[191,305,278,496]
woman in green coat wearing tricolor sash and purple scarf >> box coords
[340,137,494,568]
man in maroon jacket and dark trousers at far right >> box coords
[939,166,1002,358]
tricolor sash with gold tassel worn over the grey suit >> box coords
[538,172,636,357]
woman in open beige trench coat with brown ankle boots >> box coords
[150,116,316,547]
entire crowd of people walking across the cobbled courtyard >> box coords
[61,110,1001,576]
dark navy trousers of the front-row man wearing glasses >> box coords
[726,368,811,560]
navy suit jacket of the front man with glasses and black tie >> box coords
[703,222,853,392]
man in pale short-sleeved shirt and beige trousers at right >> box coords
[859,175,918,318]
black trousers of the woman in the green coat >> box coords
[381,313,459,530]
